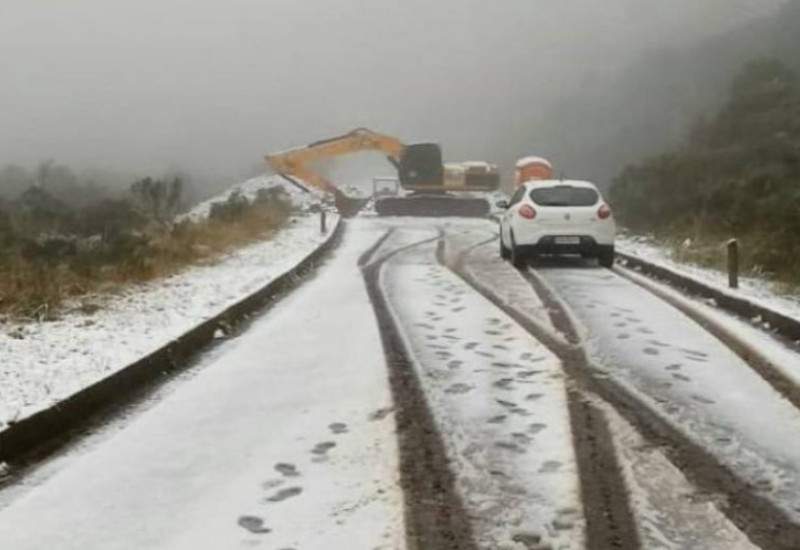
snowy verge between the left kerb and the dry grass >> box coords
[0,216,330,430]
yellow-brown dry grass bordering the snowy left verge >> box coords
[0,206,289,319]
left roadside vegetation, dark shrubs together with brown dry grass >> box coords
[0,163,293,320]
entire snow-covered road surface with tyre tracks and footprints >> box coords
[0,218,800,550]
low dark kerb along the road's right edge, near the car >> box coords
[616,251,800,342]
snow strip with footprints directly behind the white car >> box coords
[538,268,800,521]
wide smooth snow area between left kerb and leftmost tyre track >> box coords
[0,220,405,550]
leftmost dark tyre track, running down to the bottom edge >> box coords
[360,230,478,550]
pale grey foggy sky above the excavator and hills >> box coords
[0,0,780,187]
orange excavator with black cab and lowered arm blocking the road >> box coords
[265,128,500,217]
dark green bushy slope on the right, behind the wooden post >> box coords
[611,60,800,281]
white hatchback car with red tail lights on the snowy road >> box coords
[497,180,617,267]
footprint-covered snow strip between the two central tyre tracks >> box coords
[381,231,584,549]
